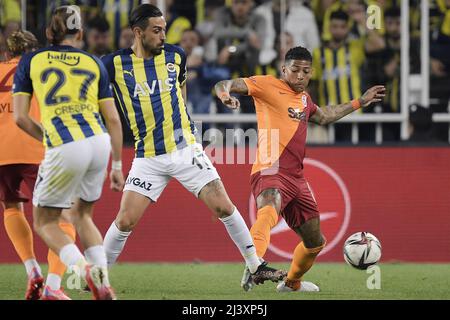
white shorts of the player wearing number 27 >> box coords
[33,133,111,208]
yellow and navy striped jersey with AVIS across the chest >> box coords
[102,44,196,158]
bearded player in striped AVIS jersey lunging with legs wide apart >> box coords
[102,4,286,283]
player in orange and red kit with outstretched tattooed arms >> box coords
[215,47,385,292]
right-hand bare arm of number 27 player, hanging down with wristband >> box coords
[99,99,124,191]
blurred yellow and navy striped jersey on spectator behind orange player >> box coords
[312,40,365,106]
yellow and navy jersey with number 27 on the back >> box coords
[13,46,113,147]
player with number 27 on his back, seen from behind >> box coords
[13,6,123,300]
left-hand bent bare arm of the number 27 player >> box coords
[13,94,44,142]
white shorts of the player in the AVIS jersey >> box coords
[124,143,220,202]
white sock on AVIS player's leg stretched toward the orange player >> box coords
[220,207,261,273]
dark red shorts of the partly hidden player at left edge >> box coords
[0,164,39,202]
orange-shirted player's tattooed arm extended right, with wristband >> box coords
[309,86,386,125]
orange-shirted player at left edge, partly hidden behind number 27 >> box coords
[0,31,76,300]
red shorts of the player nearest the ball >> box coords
[250,169,320,229]
